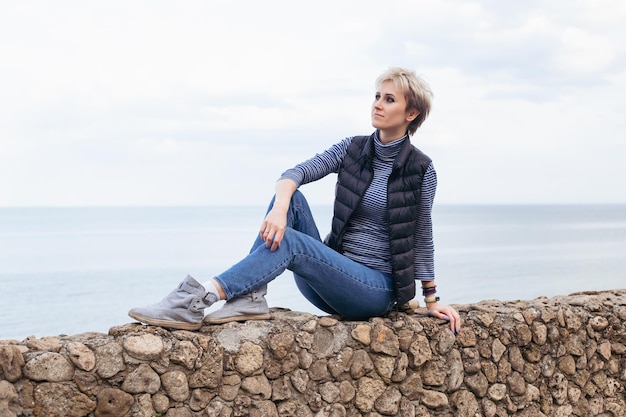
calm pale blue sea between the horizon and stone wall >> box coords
[0,205,626,340]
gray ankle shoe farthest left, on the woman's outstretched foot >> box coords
[128,275,219,330]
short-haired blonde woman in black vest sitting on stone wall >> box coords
[129,68,461,334]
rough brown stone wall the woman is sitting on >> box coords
[0,290,626,417]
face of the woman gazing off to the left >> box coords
[372,81,419,142]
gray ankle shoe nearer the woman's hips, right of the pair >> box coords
[204,285,271,324]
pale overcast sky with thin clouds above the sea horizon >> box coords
[0,0,626,206]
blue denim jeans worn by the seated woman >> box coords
[215,191,395,319]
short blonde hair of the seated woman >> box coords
[376,67,433,135]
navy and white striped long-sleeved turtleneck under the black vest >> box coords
[281,136,437,280]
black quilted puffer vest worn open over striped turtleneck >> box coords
[326,135,431,306]
